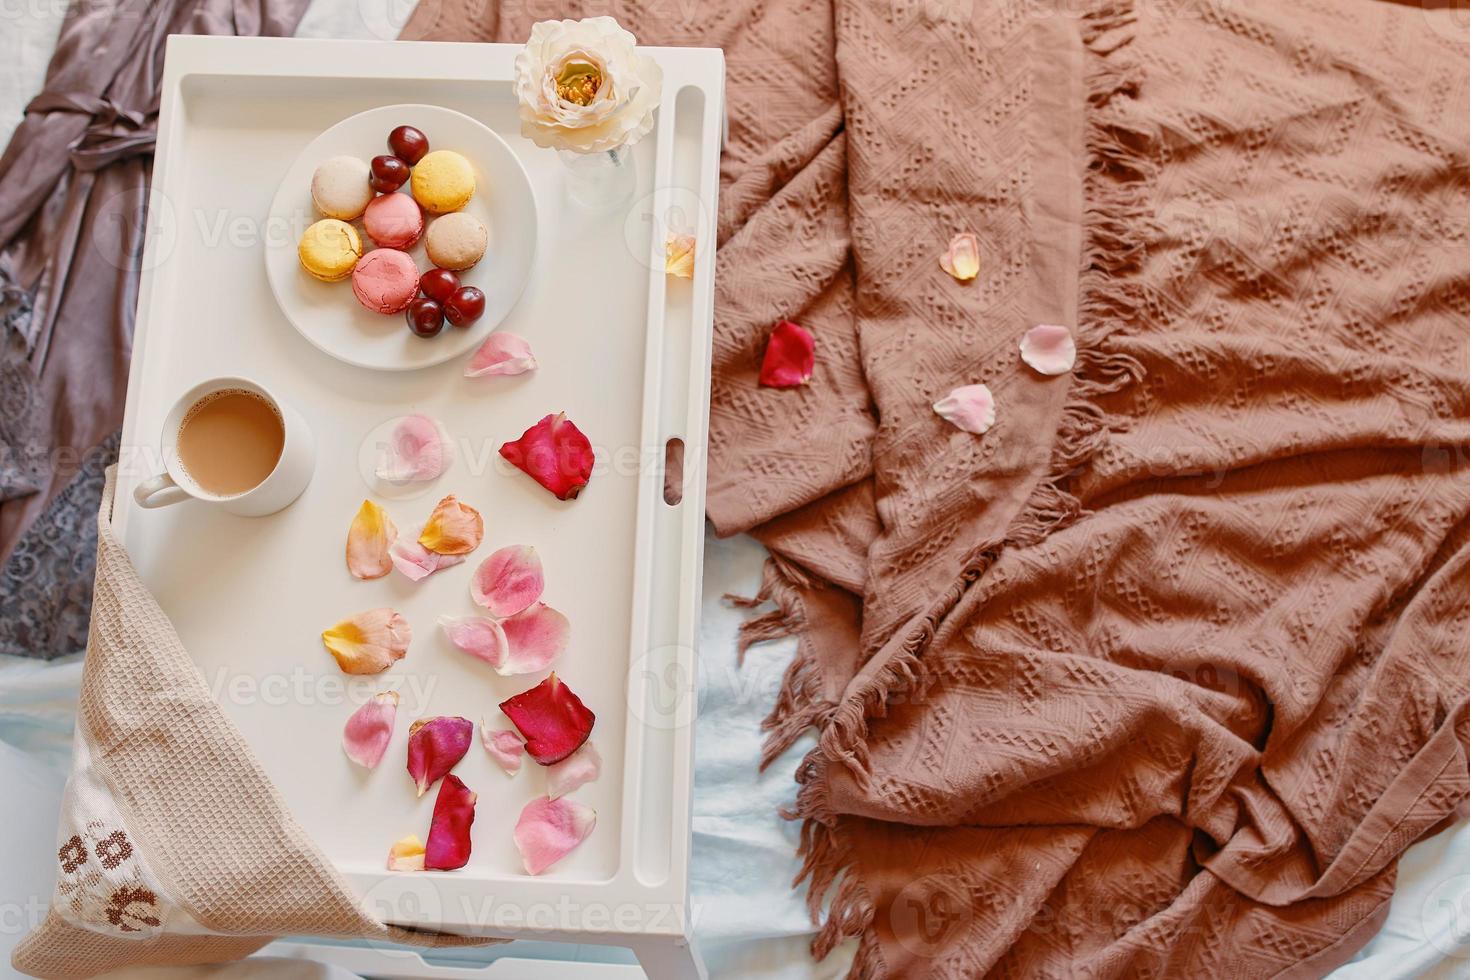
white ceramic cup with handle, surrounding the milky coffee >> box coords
[132,378,316,517]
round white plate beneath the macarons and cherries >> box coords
[265,106,537,370]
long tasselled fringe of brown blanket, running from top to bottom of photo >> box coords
[773,0,1155,977]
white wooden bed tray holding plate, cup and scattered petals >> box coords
[115,37,723,976]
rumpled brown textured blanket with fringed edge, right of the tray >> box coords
[409,0,1470,977]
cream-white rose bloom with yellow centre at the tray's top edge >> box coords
[516,18,663,153]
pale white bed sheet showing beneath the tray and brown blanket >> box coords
[0,0,1470,980]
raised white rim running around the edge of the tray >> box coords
[113,35,725,943]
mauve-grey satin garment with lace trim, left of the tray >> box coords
[0,0,307,657]
